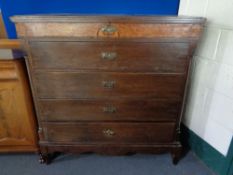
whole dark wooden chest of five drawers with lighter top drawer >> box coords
[12,16,205,163]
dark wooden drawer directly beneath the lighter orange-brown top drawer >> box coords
[30,42,189,73]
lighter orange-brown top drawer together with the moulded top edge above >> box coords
[11,15,205,39]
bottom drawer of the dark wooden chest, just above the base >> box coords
[43,122,175,144]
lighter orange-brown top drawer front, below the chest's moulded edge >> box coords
[16,19,203,39]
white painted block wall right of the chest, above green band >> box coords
[179,0,233,155]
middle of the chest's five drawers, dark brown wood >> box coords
[34,71,185,98]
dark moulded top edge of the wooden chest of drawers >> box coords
[11,15,206,24]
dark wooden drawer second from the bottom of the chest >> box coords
[38,99,181,121]
